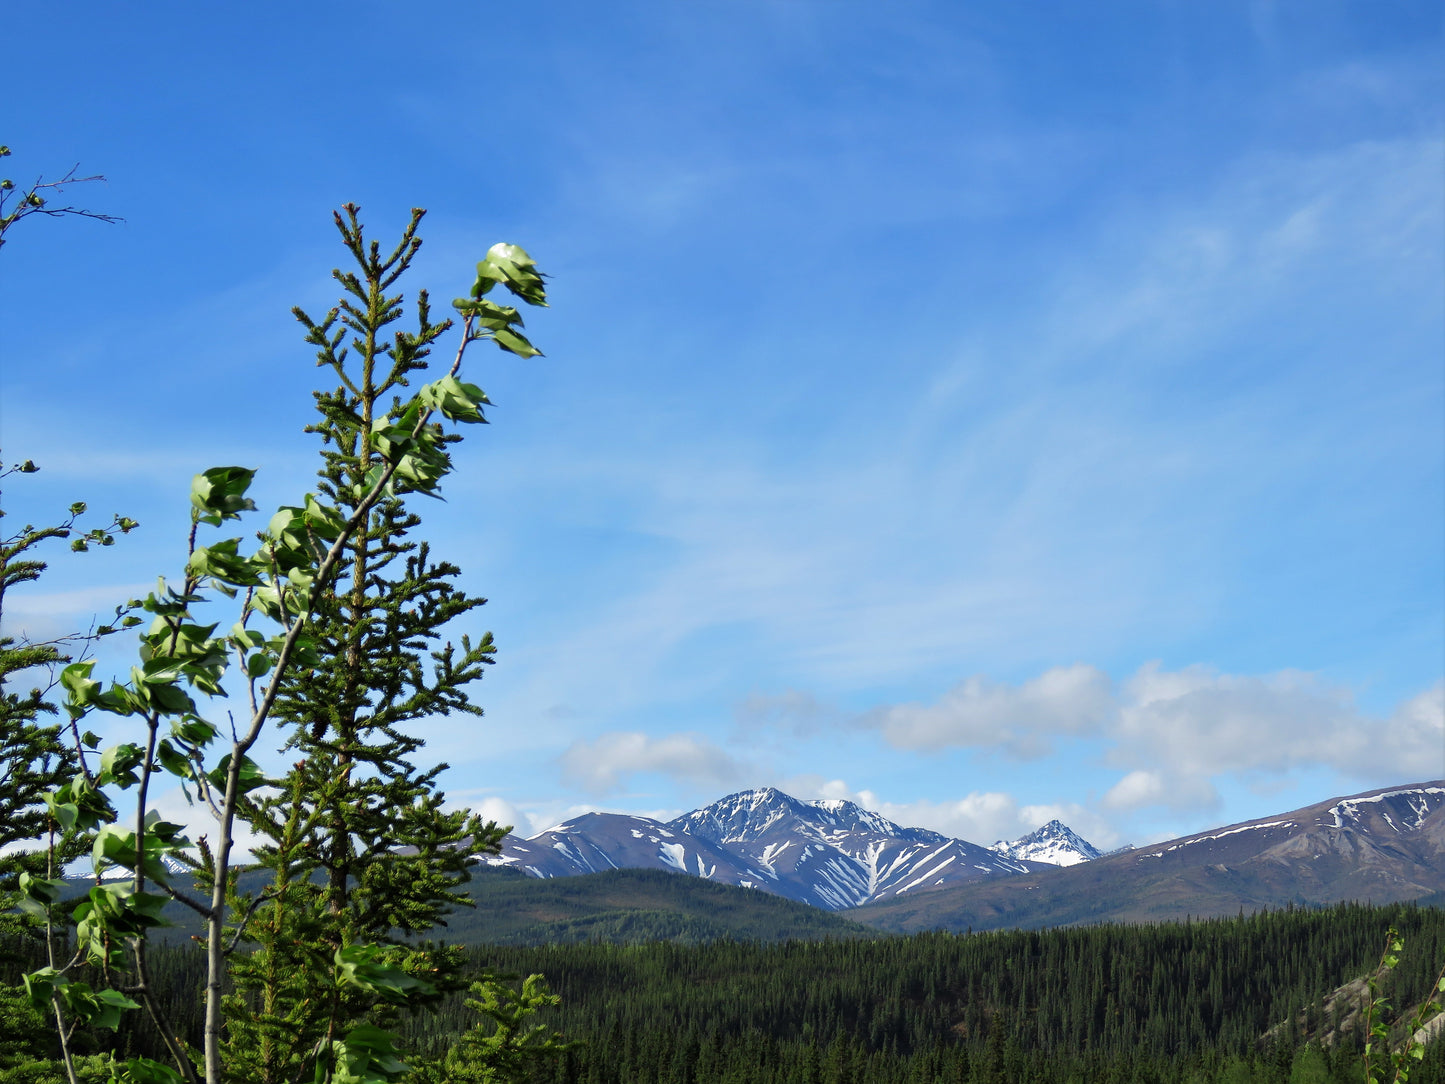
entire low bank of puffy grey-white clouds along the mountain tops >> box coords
[561,662,1445,846]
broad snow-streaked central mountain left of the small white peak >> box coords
[484,788,1069,911]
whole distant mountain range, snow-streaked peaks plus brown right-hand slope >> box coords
[484,780,1445,931]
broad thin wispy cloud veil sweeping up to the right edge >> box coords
[445,129,1441,757]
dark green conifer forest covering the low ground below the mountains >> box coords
[28,905,1445,1084]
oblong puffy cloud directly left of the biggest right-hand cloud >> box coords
[858,663,1114,759]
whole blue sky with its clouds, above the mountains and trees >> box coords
[0,0,1445,846]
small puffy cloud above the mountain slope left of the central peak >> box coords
[559,731,746,795]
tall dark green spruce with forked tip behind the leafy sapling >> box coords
[227,205,546,1084]
